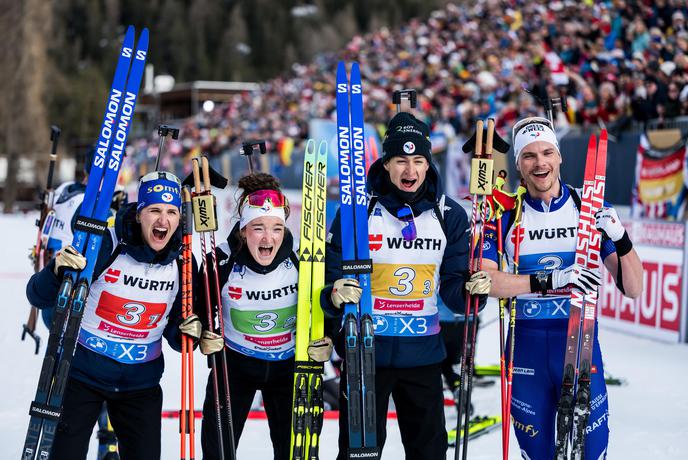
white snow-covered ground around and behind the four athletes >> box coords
[0,215,688,460]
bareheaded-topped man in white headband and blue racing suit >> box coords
[483,117,643,460]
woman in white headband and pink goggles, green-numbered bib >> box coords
[199,173,332,460]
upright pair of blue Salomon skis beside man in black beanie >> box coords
[337,62,378,458]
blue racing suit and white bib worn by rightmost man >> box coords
[483,184,616,460]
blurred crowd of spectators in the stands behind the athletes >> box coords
[135,0,688,171]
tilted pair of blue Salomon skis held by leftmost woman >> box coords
[22,26,148,460]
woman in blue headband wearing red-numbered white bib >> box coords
[26,171,195,460]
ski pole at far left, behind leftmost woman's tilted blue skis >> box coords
[22,125,62,355]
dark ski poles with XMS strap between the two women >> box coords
[192,158,234,460]
